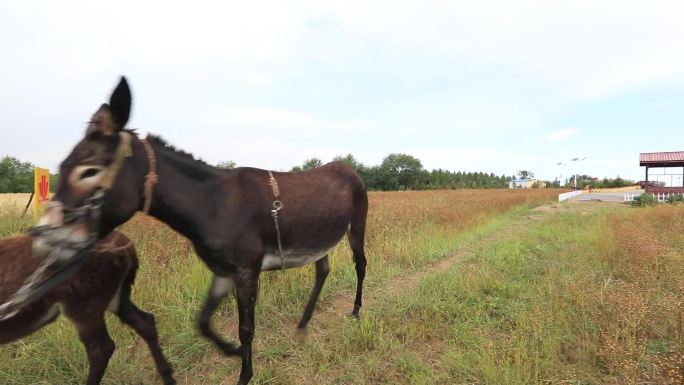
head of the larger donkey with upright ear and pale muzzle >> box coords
[40,77,147,242]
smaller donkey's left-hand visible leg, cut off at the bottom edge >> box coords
[73,313,115,385]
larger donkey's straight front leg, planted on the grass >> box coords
[235,270,259,385]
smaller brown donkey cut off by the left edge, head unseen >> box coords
[0,232,176,385]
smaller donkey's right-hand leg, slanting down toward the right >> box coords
[116,296,176,385]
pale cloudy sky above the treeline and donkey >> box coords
[0,0,684,180]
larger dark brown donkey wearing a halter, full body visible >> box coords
[38,78,368,385]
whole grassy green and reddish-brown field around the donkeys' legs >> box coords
[0,190,684,385]
